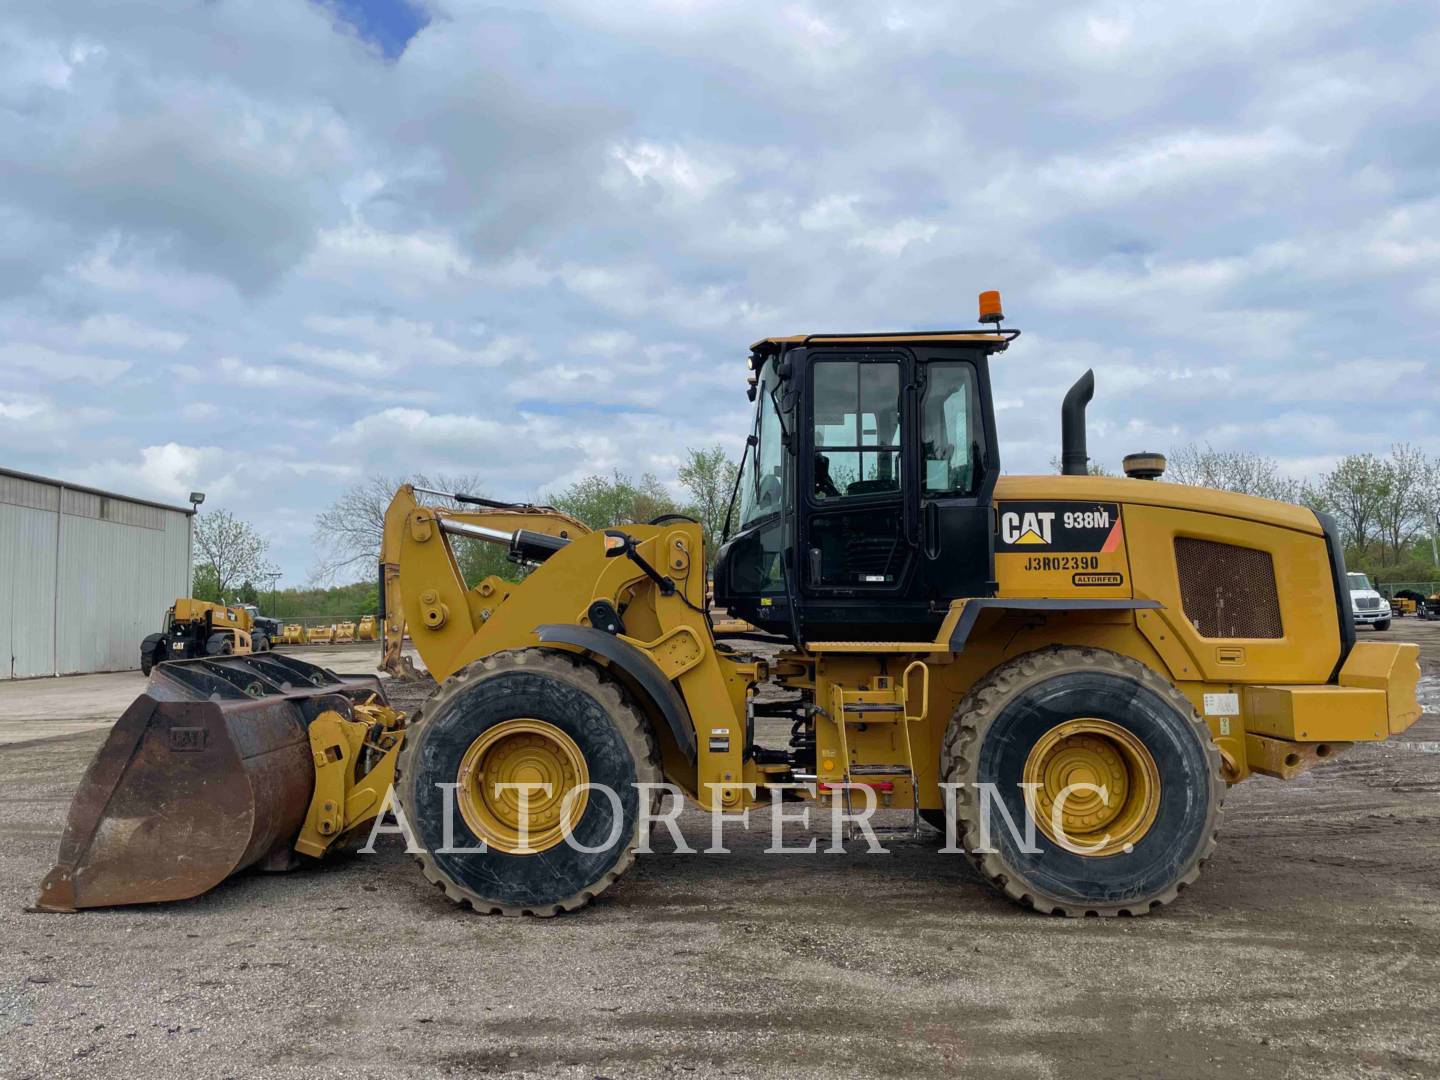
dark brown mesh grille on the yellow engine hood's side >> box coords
[1175,536,1284,638]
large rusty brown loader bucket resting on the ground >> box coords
[35,652,384,912]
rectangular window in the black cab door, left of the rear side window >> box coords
[812,360,900,501]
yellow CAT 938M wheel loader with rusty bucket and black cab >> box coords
[39,294,1420,916]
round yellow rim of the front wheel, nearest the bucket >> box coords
[455,719,590,855]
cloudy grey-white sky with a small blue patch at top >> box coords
[0,0,1440,582]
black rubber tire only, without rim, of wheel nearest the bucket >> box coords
[396,648,661,916]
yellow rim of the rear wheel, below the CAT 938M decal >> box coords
[1024,717,1161,858]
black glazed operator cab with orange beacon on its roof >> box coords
[714,294,1020,642]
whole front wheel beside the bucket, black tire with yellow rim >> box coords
[396,648,661,916]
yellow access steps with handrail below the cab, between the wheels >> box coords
[825,660,930,840]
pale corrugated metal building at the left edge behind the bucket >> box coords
[0,468,194,678]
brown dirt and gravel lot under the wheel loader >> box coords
[0,619,1440,1080]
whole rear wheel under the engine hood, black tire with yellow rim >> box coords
[940,647,1225,916]
